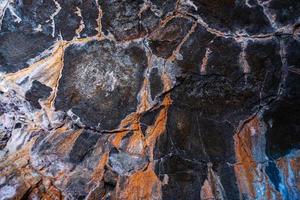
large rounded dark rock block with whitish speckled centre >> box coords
[55,40,147,130]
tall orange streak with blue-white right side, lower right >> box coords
[234,117,281,199]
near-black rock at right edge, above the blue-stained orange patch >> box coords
[265,39,300,159]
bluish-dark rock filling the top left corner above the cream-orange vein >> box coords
[0,0,55,72]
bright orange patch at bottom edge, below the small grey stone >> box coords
[116,167,161,200]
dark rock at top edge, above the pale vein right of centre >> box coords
[180,0,273,34]
